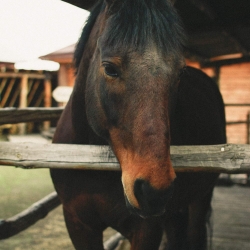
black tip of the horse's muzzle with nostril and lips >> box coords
[134,179,173,216]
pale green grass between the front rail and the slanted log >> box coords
[0,166,54,218]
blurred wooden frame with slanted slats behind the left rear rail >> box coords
[0,72,52,134]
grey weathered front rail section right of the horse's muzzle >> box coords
[171,144,250,173]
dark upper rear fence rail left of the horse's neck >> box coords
[0,108,63,125]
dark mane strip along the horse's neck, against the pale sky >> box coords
[74,0,105,71]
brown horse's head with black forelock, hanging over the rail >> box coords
[78,0,184,217]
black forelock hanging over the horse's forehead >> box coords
[105,0,185,55]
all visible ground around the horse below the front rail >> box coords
[0,136,250,250]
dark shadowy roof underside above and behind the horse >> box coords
[63,0,250,67]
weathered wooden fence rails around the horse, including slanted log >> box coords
[0,108,250,245]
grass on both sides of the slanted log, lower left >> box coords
[0,166,73,250]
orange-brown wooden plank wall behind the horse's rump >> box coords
[187,60,250,144]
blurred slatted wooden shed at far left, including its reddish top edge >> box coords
[0,62,56,134]
